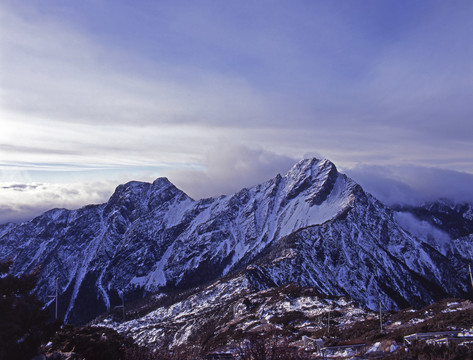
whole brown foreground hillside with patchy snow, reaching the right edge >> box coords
[94,275,473,359]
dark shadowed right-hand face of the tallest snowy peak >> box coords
[245,188,467,309]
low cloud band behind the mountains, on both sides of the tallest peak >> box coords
[0,150,473,225]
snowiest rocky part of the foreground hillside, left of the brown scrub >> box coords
[98,275,366,352]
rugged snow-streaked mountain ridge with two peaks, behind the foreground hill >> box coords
[0,159,470,323]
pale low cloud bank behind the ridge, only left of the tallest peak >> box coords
[0,143,296,224]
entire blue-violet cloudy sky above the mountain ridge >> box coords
[0,0,473,222]
